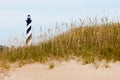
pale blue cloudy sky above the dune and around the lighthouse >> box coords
[0,0,120,45]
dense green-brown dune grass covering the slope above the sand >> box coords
[0,18,120,66]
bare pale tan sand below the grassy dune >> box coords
[0,60,120,80]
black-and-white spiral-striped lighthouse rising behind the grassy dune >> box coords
[26,15,32,45]
